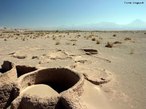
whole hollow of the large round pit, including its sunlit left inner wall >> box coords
[21,68,80,93]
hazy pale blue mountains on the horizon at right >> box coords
[69,19,146,30]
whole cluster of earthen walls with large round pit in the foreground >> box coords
[0,61,85,109]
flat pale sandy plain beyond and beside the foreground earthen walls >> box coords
[0,31,146,109]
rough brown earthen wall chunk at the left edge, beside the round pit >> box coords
[0,61,18,109]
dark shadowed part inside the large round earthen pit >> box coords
[36,68,80,93]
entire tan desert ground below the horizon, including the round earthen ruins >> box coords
[0,29,146,109]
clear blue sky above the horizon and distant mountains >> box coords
[0,0,146,28]
